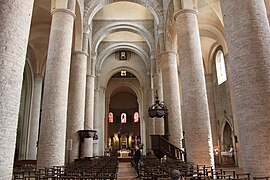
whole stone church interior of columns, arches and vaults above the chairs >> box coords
[0,0,270,180]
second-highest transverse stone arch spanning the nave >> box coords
[92,22,155,52]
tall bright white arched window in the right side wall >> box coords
[216,50,227,85]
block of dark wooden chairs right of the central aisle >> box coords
[136,156,270,180]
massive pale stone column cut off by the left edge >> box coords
[0,0,34,179]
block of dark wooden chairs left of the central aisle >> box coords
[13,156,118,180]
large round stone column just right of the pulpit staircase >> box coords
[175,9,214,166]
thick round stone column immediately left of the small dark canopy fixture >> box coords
[67,51,87,162]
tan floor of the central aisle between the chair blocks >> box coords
[117,162,137,180]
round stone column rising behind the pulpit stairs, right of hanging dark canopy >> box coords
[160,51,183,148]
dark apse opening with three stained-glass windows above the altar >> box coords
[107,72,141,157]
